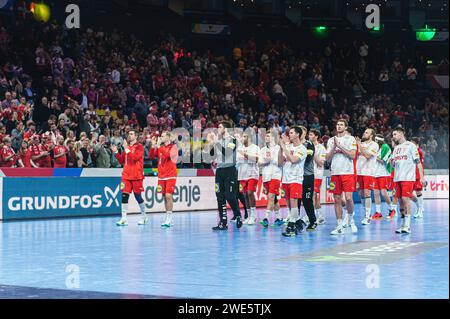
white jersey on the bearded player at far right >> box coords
[391,141,420,182]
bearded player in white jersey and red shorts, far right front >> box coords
[391,127,423,234]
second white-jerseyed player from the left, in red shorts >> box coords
[258,130,283,227]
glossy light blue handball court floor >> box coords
[0,200,449,299]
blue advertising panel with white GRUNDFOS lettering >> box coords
[2,177,121,220]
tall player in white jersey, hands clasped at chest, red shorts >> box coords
[327,119,358,235]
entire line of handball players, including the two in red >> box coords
[112,120,423,236]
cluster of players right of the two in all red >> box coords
[204,120,424,237]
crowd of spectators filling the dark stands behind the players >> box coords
[0,18,448,168]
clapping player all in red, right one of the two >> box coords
[149,131,178,227]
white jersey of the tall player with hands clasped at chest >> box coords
[327,135,356,175]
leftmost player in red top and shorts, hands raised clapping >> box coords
[111,130,148,226]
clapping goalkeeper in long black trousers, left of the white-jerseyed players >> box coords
[208,121,242,230]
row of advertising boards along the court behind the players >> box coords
[0,168,449,220]
